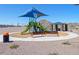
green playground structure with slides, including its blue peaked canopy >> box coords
[20,8,47,33]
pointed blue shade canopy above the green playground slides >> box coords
[20,8,47,18]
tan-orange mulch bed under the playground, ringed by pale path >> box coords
[10,31,68,38]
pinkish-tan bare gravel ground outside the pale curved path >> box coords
[0,28,79,55]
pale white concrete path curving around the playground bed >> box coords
[0,32,78,42]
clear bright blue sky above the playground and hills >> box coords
[0,4,79,25]
